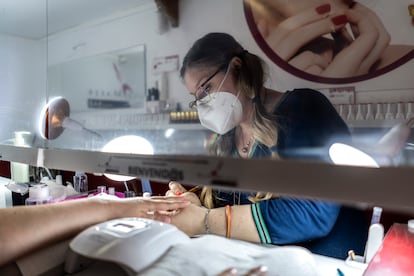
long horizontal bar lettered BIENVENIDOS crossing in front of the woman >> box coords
[0,145,414,211]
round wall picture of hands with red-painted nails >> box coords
[245,0,413,78]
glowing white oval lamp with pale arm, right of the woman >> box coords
[329,118,414,167]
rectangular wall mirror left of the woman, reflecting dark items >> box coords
[47,45,146,112]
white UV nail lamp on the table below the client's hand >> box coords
[65,218,190,275]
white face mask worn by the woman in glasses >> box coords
[197,92,243,135]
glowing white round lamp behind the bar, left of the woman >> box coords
[101,135,154,193]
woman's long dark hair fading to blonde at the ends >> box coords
[180,33,278,208]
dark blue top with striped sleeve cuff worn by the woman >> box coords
[215,89,366,257]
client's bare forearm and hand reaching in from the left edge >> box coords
[0,197,189,265]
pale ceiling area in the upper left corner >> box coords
[0,0,154,39]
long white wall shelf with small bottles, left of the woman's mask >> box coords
[71,108,204,130]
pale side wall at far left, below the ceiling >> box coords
[0,34,46,141]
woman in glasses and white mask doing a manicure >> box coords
[163,33,368,257]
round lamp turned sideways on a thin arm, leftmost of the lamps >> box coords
[39,97,101,140]
